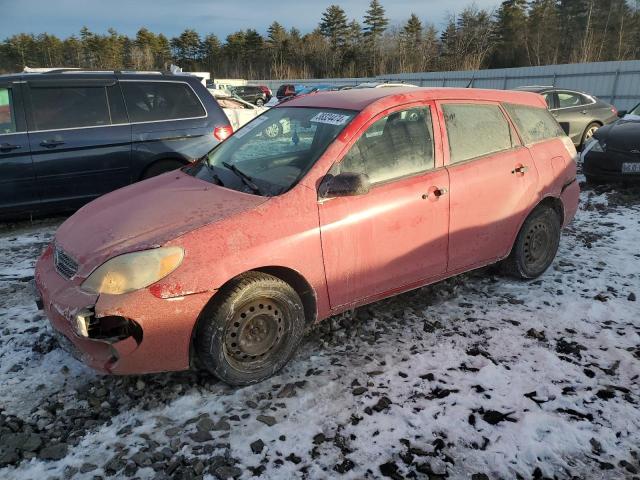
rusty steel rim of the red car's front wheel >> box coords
[224,298,286,372]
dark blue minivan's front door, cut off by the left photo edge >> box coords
[0,82,39,215]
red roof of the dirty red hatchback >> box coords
[276,87,547,111]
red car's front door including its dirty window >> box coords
[319,105,449,308]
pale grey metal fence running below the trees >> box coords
[250,60,640,109]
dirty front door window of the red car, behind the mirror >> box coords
[331,107,435,184]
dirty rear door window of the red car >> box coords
[442,103,515,163]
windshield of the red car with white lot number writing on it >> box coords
[186,107,357,196]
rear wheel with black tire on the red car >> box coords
[502,206,561,280]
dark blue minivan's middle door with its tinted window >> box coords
[27,78,131,208]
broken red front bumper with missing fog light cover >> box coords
[35,247,210,375]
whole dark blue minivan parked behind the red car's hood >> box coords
[0,70,231,219]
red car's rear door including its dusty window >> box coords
[439,101,538,273]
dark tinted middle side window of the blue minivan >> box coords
[30,85,111,130]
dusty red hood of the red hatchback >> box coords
[55,171,267,277]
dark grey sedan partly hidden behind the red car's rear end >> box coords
[516,86,618,149]
